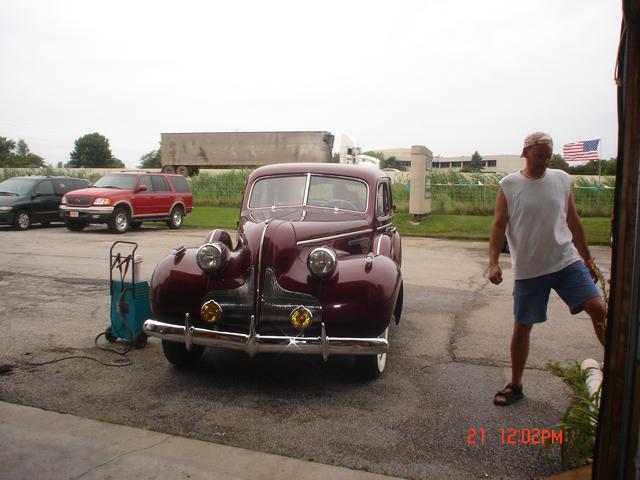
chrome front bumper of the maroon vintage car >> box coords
[144,314,389,361]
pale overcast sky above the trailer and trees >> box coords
[0,0,621,167]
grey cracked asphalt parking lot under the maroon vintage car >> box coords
[0,226,610,479]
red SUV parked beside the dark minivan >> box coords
[60,172,193,233]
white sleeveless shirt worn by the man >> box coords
[500,169,580,280]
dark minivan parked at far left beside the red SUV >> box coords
[0,175,89,230]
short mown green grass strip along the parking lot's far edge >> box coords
[184,207,611,245]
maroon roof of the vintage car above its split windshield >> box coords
[249,163,388,184]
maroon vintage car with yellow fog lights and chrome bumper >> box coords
[144,164,402,377]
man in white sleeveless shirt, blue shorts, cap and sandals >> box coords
[489,132,605,406]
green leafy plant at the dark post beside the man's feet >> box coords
[545,362,600,467]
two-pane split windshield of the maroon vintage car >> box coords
[249,175,367,212]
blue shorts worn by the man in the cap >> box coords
[513,260,600,325]
